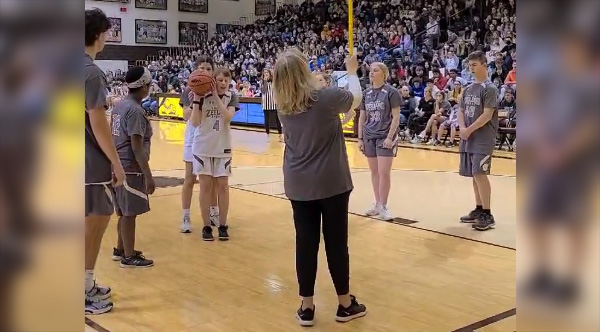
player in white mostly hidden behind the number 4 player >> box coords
[179,56,219,233]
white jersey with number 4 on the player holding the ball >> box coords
[192,91,238,158]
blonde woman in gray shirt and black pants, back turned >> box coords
[273,50,366,326]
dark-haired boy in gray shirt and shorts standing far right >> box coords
[458,51,498,231]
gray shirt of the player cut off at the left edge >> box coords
[84,54,112,184]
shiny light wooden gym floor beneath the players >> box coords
[86,121,516,332]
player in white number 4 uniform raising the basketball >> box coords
[190,68,239,241]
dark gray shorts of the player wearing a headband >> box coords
[114,174,150,217]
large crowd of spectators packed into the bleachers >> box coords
[106,0,516,148]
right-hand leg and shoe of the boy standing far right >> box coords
[471,154,496,231]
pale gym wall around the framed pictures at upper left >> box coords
[85,0,254,46]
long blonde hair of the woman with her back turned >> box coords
[273,49,319,115]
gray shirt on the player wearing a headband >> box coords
[111,96,152,173]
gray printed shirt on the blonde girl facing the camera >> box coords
[360,84,402,139]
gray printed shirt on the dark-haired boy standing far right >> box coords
[459,81,498,155]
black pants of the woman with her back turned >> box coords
[291,191,350,297]
